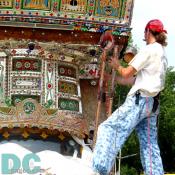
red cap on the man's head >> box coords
[145,19,167,33]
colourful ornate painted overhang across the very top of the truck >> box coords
[0,0,134,29]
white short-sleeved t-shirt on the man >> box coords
[128,42,168,97]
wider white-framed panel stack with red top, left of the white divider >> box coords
[6,49,43,105]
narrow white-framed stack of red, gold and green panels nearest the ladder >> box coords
[57,62,82,113]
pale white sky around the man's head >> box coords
[131,0,175,67]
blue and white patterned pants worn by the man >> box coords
[92,96,164,175]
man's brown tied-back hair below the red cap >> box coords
[150,30,168,46]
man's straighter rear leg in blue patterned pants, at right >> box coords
[136,114,164,175]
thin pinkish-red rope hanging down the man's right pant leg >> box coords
[146,97,152,175]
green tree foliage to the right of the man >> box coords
[159,67,175,172]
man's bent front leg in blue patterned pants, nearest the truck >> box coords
[93,96,139,175]
